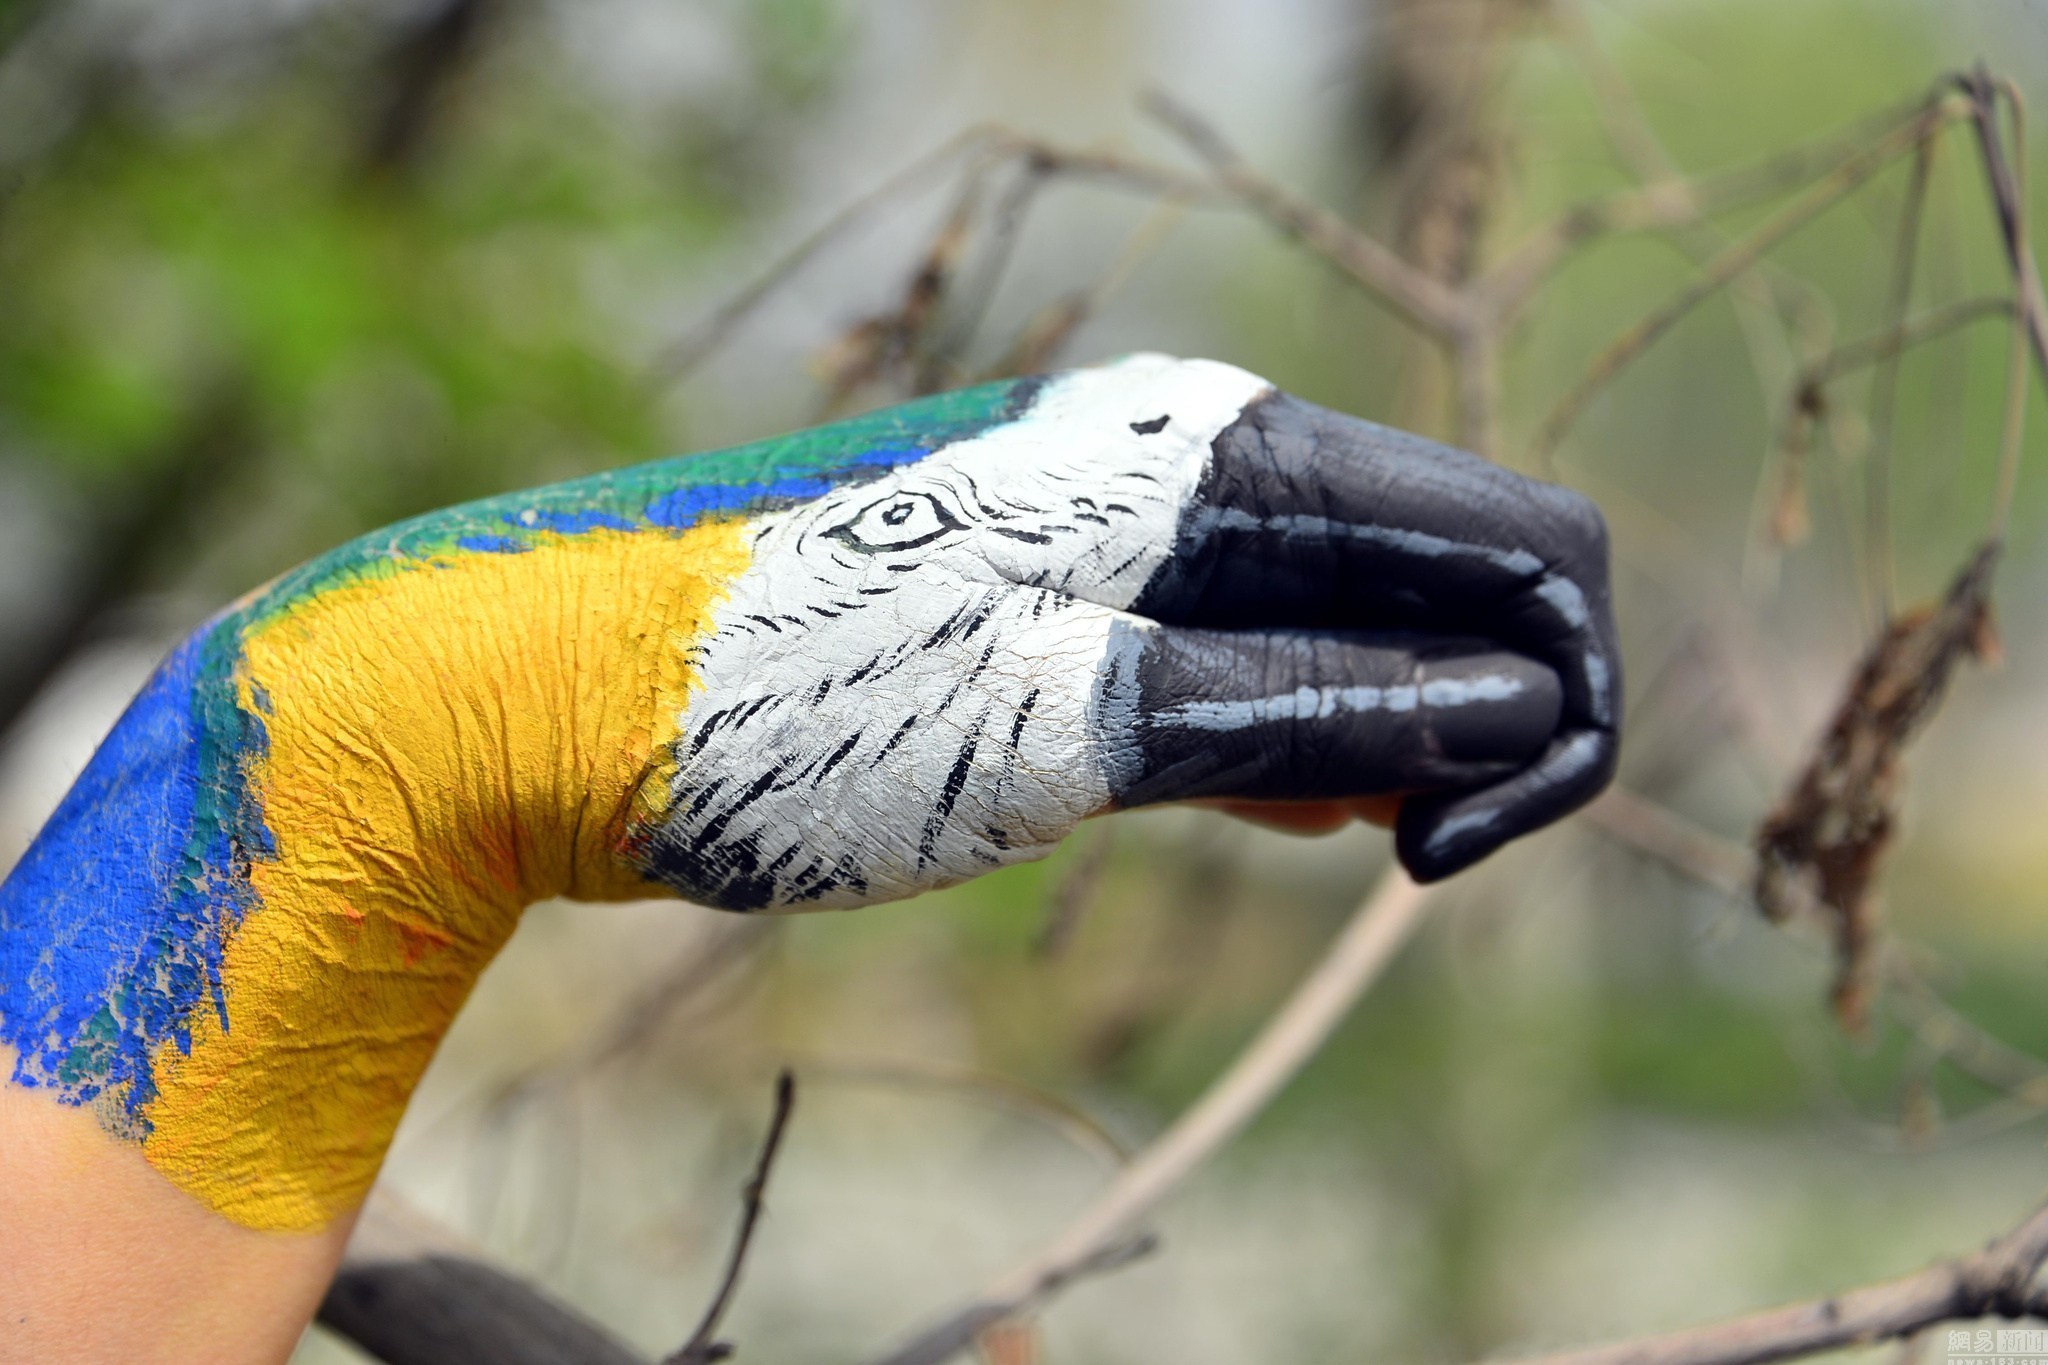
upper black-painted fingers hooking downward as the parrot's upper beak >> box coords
[1135,393,1620,880]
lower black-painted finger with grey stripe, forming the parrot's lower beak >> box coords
[1096,626,1559,806]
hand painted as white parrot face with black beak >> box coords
[663,356,1620,909]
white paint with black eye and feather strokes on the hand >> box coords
[664,356,1270,909]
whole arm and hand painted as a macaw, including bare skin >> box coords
[0,356,1620,1361]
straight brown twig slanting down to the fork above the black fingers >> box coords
[1143,90,1466,340]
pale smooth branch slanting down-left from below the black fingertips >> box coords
[881,870,1430,1365]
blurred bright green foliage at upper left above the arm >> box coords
[0,0,838,596]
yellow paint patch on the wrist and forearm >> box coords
[143,522,748,1230]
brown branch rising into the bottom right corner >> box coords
[1511,1207,2048,1365]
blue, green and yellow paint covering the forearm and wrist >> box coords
[0,381,1034,1230]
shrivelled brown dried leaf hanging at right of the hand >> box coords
[1755,542,1999,1031]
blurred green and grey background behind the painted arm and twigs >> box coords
[0,0,2048,1365]
